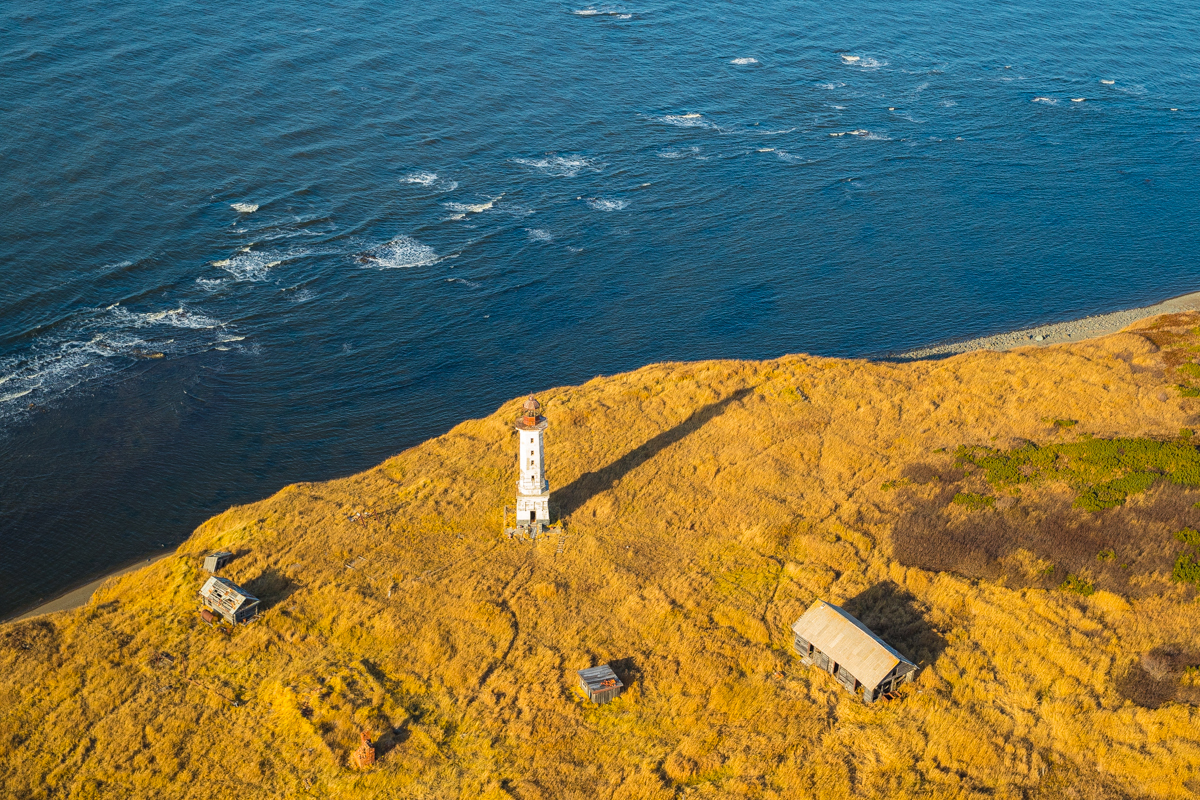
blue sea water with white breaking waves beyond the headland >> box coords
[0,0,1200,613]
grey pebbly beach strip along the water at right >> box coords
[890,291,1200,361]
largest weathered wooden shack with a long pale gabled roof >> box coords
[792,600,917,703]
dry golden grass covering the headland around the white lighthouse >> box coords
[0,315,1200,800]
